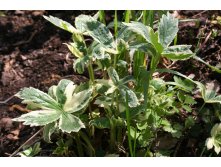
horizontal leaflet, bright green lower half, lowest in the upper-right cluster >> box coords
[162,45,194,60]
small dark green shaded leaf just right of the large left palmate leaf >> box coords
[90,117,110,129]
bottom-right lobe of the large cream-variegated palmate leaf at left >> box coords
[59,113,85,133]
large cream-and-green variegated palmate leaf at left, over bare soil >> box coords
[13,79,92,134]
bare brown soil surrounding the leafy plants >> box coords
[0,11,221,156]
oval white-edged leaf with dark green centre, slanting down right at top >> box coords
[75,15,115,48]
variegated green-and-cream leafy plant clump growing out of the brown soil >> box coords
[1,11,221,157]
